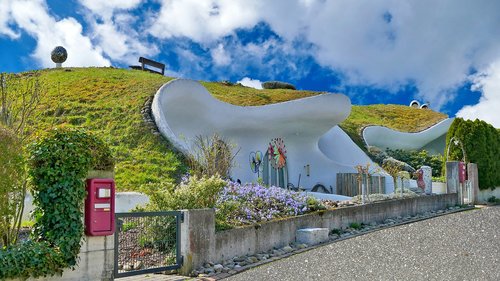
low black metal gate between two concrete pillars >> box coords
[114,211,183,278]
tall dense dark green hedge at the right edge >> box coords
[443,118,500,189]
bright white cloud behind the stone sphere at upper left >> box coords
[9,0,110,67]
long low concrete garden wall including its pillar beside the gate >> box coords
[181,193,458,274]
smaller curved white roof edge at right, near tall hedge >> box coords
[363,118,454,150]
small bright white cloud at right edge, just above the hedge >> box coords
[457,60,500,128]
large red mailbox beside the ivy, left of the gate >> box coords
[85,179,115,236]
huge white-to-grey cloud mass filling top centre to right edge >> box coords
[150,0,500,109]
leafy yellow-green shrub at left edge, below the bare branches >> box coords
[0,125,26,247]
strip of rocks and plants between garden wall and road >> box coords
[193,203,475,281]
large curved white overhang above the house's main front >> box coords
[152,79,351,152]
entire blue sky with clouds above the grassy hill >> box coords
[0,0,500,128]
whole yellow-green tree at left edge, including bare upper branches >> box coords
[0,73,45,246]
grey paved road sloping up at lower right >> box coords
[224,206,500,281]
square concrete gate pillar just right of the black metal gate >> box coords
[180,209,215,276]
